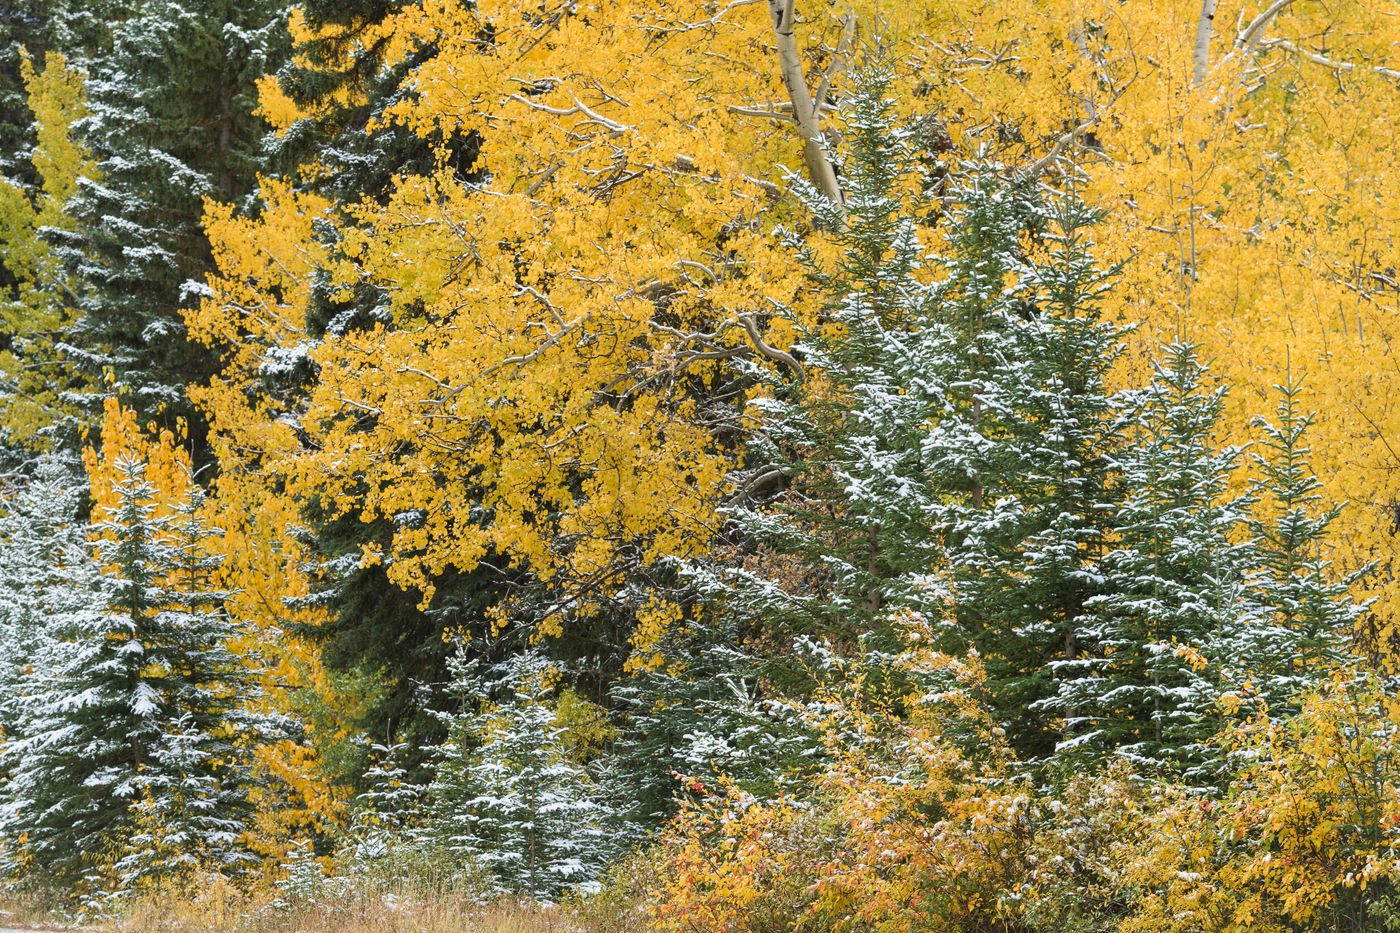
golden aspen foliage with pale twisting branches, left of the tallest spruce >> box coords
[189,3,851,644]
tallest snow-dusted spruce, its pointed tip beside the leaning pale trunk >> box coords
[711,73,948,652]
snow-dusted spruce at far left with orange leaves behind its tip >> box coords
[0,458,272,890]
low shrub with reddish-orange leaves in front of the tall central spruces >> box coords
[651,638,1173,933]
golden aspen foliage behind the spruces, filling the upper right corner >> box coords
[884,0,1400,651]
